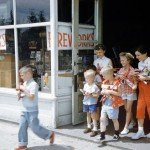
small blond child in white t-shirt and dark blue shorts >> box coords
[82,69,99,137]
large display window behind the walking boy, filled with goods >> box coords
[18,27,51,92]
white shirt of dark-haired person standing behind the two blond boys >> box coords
[93,56,111,69]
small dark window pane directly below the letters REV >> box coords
[58,50,72,71]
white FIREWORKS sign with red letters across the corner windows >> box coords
[46,25,94,50]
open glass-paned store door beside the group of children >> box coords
[72,0,95,125]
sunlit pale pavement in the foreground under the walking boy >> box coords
[0,121,108,150]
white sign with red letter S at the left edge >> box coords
[0,30,6,50]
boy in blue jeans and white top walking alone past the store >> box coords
[15,66,55,150]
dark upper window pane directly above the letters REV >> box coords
[58,0,72,22]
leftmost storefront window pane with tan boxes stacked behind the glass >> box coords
[0,29,16,88]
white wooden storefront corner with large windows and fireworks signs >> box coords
[0,0,102,128]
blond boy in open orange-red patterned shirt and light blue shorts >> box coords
[99,66,123,141]
